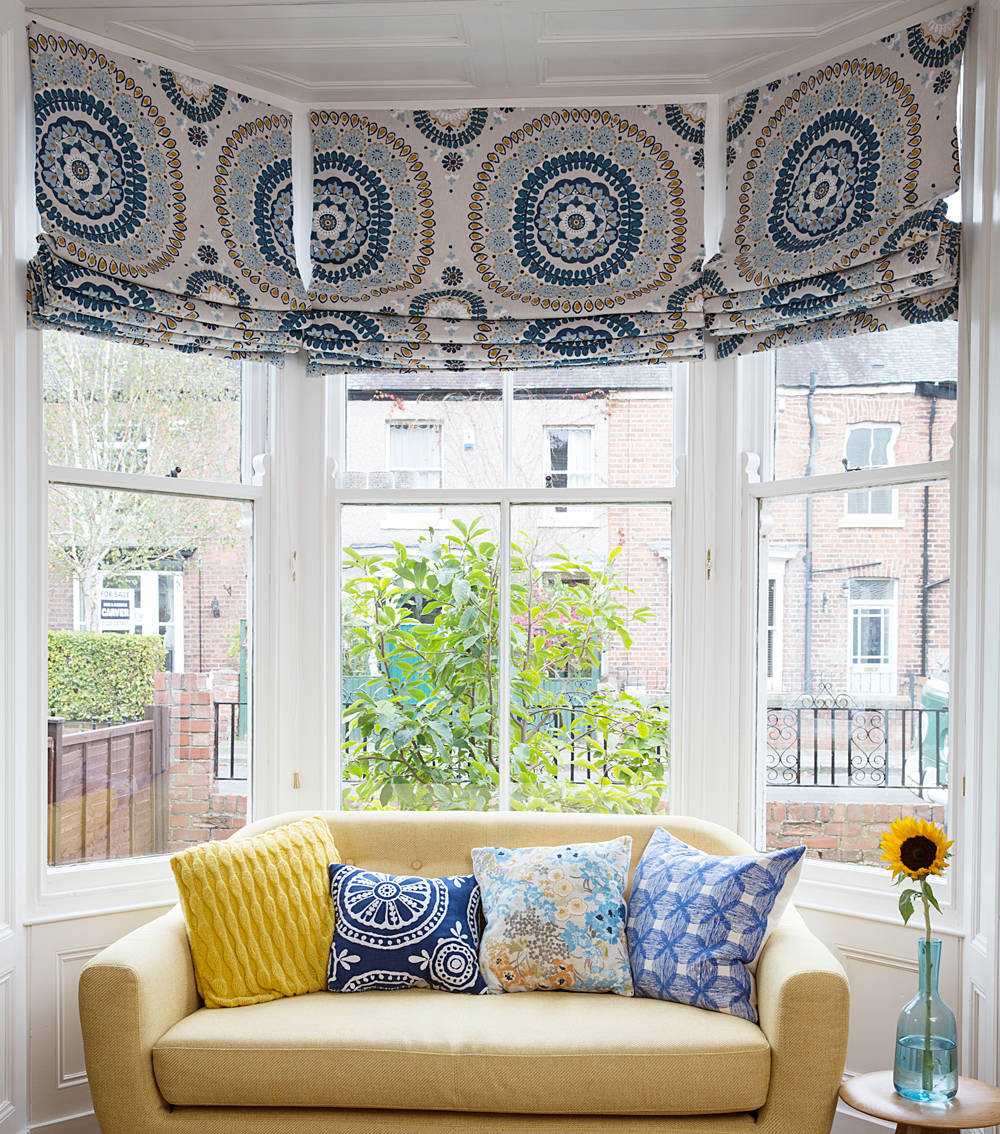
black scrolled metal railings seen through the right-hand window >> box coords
[766,703,948,790]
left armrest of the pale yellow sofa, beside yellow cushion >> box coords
[79,906,201,1134]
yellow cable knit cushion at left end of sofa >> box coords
[170,816,339,1008]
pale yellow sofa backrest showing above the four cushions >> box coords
[230,811,754,898]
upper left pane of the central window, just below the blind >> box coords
[344,372,503,492]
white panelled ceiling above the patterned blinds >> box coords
[23,0,947,108]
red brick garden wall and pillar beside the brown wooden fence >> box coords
[154,674,246,854]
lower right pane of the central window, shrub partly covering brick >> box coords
[510,506,670,813]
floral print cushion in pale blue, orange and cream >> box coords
[472,836,632,996]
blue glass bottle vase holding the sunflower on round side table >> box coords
[892,938,958,1102]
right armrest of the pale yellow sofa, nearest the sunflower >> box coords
[757,906,850,1134]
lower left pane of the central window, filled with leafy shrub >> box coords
[341,507,500,811]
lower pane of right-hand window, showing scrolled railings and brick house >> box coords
[762,483,950,864]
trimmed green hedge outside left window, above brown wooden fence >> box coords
[49,631,166,721]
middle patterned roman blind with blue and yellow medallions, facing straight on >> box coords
[302,104,705,370]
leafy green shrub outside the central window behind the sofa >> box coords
[344,519,668,813]
